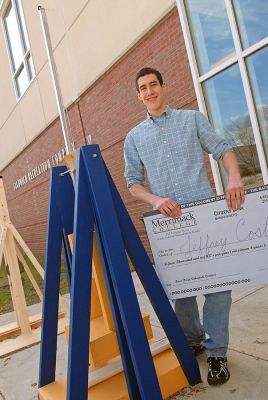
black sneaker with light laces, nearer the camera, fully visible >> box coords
[207,357,230,385]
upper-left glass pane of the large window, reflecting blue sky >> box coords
[184,0,234,74]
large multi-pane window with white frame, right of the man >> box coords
[177,0,268,192]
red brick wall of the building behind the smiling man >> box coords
[2,10,212,260]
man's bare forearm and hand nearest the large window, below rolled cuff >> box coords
[222,151,245,209]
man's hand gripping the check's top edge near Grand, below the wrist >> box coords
[226,173,245,210]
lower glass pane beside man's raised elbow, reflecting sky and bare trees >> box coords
[203,64,263,187]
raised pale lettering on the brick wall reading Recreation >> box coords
[13,149,66,190]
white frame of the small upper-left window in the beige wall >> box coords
[1,0,35,101]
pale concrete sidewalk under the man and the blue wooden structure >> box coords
[0,273,268,400]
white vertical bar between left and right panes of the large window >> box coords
[225,0,268,184]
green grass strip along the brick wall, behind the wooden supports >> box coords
[0,257,69,314]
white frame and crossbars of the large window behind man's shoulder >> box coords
[176,0,268,194]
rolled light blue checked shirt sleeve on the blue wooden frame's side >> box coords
[124,133,145,188]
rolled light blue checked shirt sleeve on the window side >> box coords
[195,111,233,160]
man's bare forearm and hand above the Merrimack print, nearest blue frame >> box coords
[129,183,181,218]
